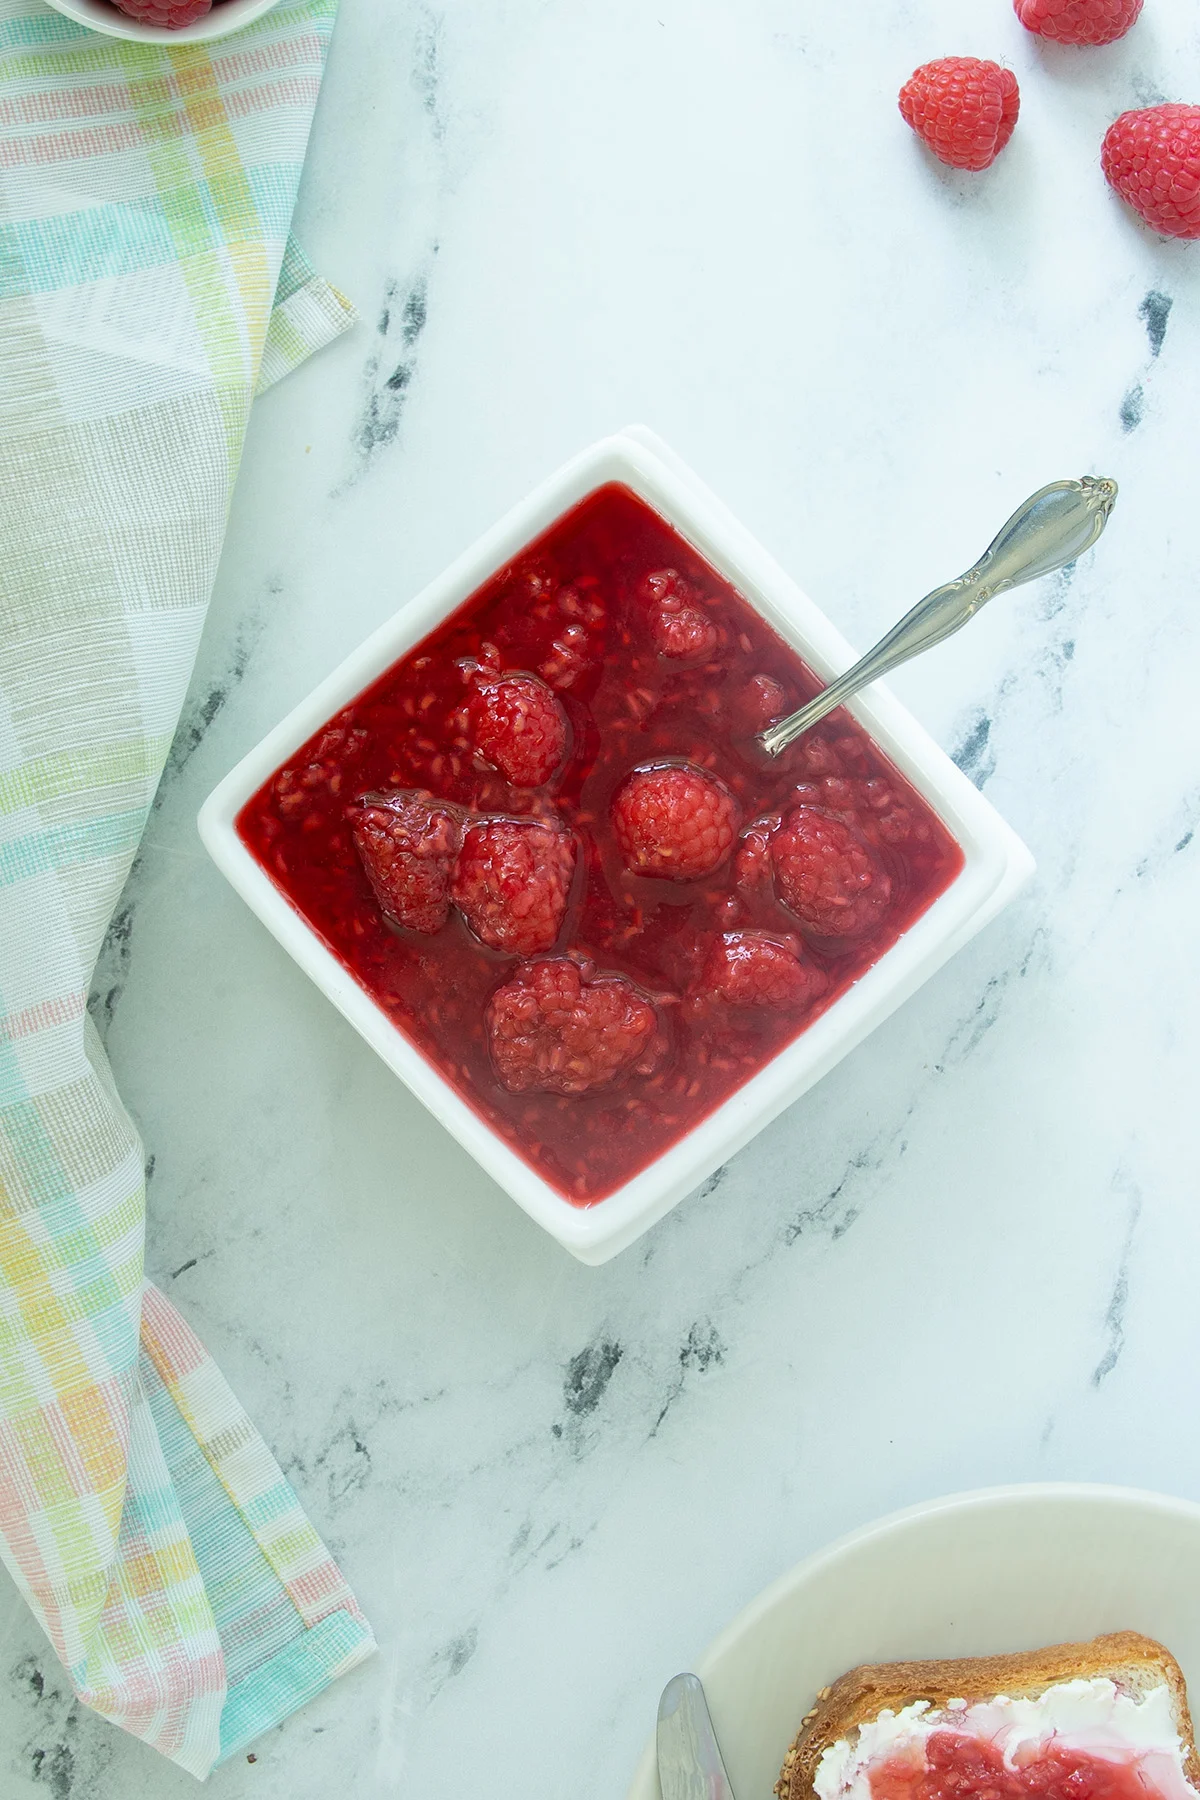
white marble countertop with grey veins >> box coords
[0,0,1200,1800]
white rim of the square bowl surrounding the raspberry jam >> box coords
[200,427,1033,1264]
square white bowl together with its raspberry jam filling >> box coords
[200,427,1033,1264]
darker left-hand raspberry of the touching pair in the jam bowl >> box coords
[349,792,462,936]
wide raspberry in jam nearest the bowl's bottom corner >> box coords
[486,956,664,1094]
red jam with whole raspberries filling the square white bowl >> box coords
[237,484,963,1206]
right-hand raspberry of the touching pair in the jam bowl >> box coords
[450,819,576,956]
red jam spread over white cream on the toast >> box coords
[867,1732,1155,1800]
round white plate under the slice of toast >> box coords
[628,1483,1200,1800]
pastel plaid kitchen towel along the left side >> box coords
[0,0,372,1777]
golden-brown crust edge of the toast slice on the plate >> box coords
[775,1631,1200,1800]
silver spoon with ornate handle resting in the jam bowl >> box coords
[759,475,1117,756]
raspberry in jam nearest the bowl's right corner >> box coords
[770,806,892,938]
